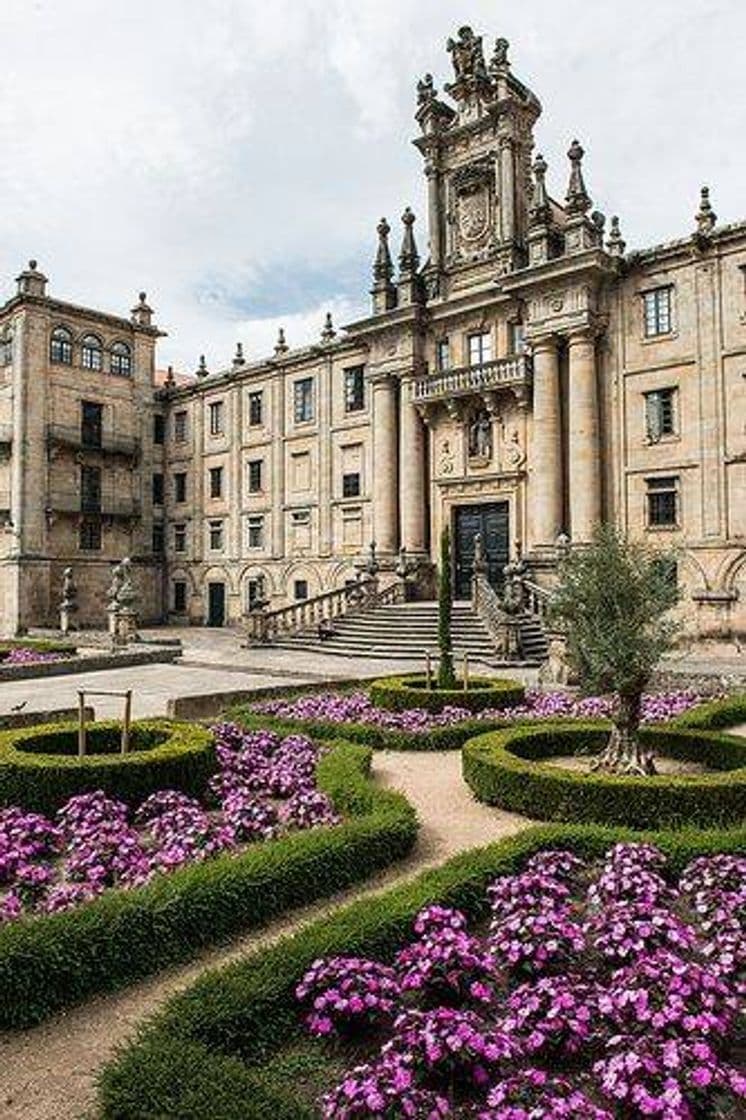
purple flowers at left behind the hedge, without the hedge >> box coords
[0,725,338,924]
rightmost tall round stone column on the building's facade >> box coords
[568,330,602,543]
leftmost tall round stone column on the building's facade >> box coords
[372,376,399,556]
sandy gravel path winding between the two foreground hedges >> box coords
[0,750,531,1120]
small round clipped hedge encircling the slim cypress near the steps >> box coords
[369,674,525,712]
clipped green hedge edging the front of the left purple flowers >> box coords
[0,744,418,1029]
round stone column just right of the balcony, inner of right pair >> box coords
[529,336,562,545]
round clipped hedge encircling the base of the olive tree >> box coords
[461,722,746,829]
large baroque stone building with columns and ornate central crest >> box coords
[0,27,746,636]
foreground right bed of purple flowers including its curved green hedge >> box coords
[95,825,746,1120]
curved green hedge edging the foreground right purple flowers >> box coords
[99,825,746,1120]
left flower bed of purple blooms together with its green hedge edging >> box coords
[0,727,417,1027]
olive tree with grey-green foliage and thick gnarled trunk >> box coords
[550,525,679,774]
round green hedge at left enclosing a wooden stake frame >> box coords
[0,719,215,813]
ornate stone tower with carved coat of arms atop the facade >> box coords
[414,27,541,297]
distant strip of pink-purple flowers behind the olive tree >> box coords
[239,690,701,750]
